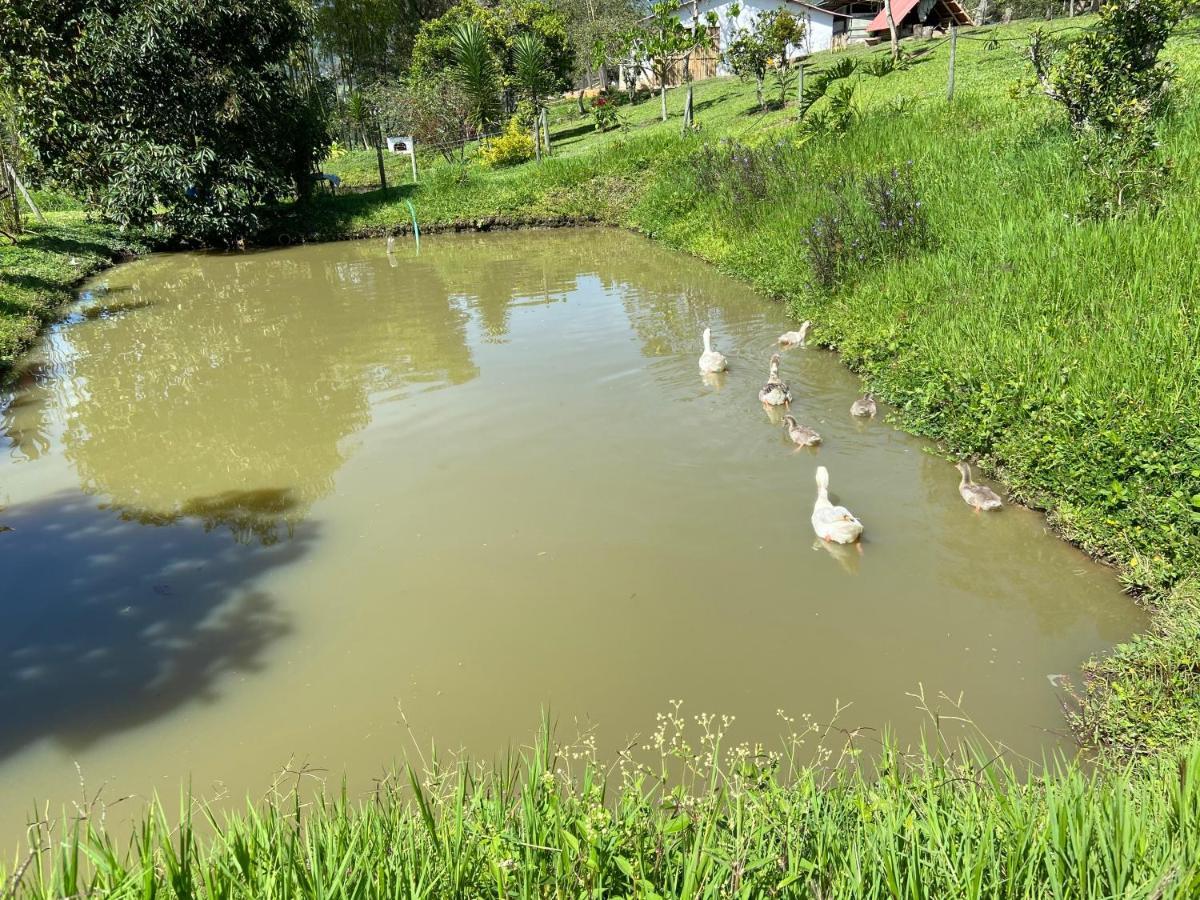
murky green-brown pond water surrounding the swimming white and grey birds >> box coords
[0,230,1142,846]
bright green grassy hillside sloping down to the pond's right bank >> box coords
[272,17,1200,755]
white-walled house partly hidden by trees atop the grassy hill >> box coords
[619,0,850,88]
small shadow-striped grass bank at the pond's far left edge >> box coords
[0,212,143,380]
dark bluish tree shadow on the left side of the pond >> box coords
[0,491,317,756]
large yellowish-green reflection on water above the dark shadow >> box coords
[51,247,478,532]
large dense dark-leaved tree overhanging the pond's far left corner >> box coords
[0,0,328,242]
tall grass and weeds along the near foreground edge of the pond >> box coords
[0,707,1200,900]
